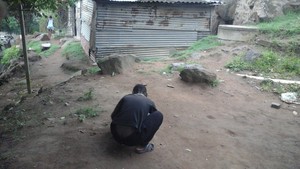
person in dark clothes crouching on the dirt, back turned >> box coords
[110,84,163,154]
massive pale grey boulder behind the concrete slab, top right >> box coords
[216,0,300,25]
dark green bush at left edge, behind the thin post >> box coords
[0,16,21,34]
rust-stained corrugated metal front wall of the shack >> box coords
[95,2,212,57]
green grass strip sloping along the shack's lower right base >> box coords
[171,36,221,60]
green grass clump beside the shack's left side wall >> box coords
[62,42,86,60]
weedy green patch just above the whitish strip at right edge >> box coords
[225,51,300,78]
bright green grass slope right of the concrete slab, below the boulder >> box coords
[258,12,300,37]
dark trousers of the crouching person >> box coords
[110,111,163,146]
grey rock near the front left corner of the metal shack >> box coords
[97,54,139,75]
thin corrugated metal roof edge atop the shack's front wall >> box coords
[110,0,221,4]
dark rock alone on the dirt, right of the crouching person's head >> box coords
[180,64,217,84]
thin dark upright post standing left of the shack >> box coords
[19,4,31,94]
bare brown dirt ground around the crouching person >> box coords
[0,39,300,169]
